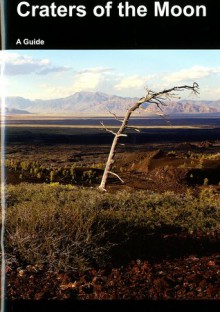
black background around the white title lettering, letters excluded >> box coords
[3,0,220,50]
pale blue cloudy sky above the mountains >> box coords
[0,50,220,100]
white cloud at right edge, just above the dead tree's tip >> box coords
[162,66,220,83]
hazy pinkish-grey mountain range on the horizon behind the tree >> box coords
[2,92,220,115]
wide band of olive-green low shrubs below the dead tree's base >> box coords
[5,183,220,270]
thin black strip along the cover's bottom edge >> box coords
[6,300,219,312]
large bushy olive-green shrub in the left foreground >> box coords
[5,184,115,269]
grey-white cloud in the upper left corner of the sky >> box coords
[0,52,70,76]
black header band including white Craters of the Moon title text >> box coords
[2,0,220,49]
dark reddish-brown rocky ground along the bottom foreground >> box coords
[6,240,220,300]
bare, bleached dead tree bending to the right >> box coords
[99,82,199,191]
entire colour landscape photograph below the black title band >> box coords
[1,50,220,301]
